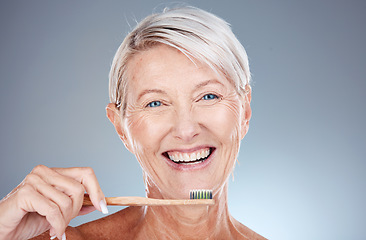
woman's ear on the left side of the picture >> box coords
[106,103,133,153]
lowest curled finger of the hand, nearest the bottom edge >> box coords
[17,184,67,239]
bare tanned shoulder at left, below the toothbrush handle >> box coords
[32,207,142,240]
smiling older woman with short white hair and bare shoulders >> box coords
[0,7,264,239]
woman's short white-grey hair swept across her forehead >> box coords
[109,7,250,116]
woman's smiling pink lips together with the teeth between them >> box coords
[162,147,215,170]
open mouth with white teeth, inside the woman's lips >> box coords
[163,147,214,165]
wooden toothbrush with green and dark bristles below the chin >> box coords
[83,190,215,206]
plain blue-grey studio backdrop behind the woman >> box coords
[0,0,366,240]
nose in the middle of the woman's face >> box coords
[173,107,201,143]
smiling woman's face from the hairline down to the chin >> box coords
[116,45,250,198]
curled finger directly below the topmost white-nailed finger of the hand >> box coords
[30,165,85,217]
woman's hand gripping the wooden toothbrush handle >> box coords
[0,165,107,240]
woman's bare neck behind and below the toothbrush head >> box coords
[139,184,235,239]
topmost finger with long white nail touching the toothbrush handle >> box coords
[53,167,108,213]
